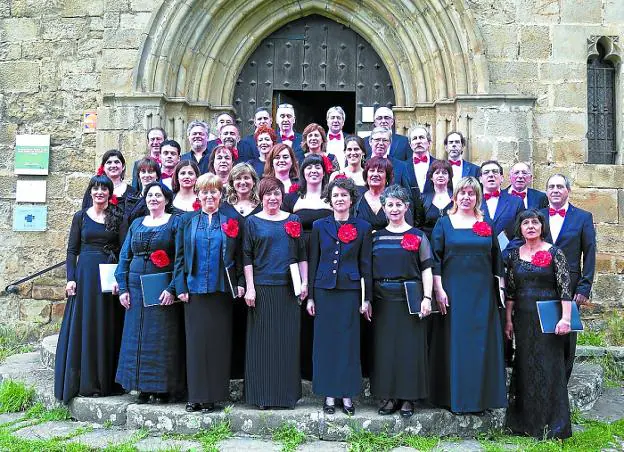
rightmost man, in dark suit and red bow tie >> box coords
[541,174,596,380]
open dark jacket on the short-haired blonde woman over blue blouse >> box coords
[173,209,245,294]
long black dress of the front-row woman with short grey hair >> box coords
[371,228,433,400]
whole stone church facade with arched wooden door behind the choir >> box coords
[0,0,624,321]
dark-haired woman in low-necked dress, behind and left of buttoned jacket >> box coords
[282,154,332,380]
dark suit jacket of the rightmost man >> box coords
[541,204,596,298]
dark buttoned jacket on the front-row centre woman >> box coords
[308,215,373,300]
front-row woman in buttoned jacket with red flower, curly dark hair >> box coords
[306,177,372,415]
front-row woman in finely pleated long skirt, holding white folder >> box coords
[243,177,308,409]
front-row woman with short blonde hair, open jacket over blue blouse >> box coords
[174,173,244,413]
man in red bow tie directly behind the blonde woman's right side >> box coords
[480,160,525,240]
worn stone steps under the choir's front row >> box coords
[0,336,603,441]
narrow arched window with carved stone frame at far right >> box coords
[587,36,621,165]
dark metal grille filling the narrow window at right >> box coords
[587,43,617,164]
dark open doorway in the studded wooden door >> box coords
[273,91,355,134]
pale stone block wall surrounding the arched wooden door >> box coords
[0,0,624,321]
